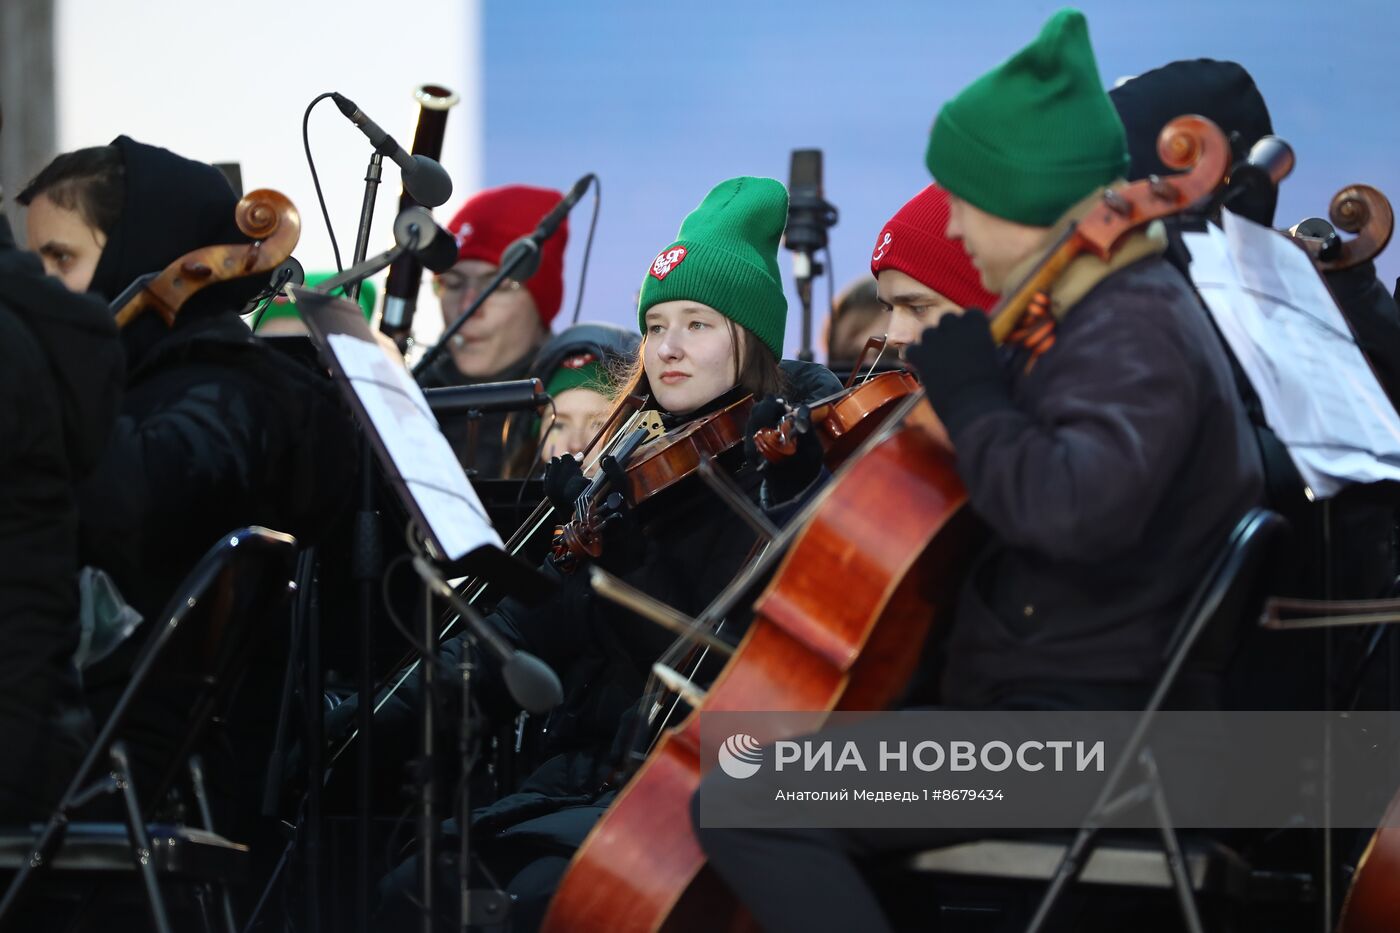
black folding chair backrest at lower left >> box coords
[102,527,297,803]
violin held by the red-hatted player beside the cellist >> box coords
[753,336,918,471]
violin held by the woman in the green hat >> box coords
[553,395,753,570]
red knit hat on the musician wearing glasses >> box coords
[448,185,568,331]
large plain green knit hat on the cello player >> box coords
[925,10,1128,227]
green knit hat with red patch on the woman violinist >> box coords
[637,175,787,359]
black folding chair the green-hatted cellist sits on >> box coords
[909,509,1288,933]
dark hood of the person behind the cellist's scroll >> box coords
[1109,59,1278,226]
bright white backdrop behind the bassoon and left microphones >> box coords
[55,0,482,340]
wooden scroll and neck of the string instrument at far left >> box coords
[116,188,301,328]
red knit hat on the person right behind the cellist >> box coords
[871,185,997,311]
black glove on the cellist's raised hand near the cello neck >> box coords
[904,308,1011,436]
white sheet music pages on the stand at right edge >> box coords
[1184,212,1400,499]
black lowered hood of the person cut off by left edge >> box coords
[0,216,125,476]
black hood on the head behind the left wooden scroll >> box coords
[88,136,267,367]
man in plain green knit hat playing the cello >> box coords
[696,10,1261,932]
